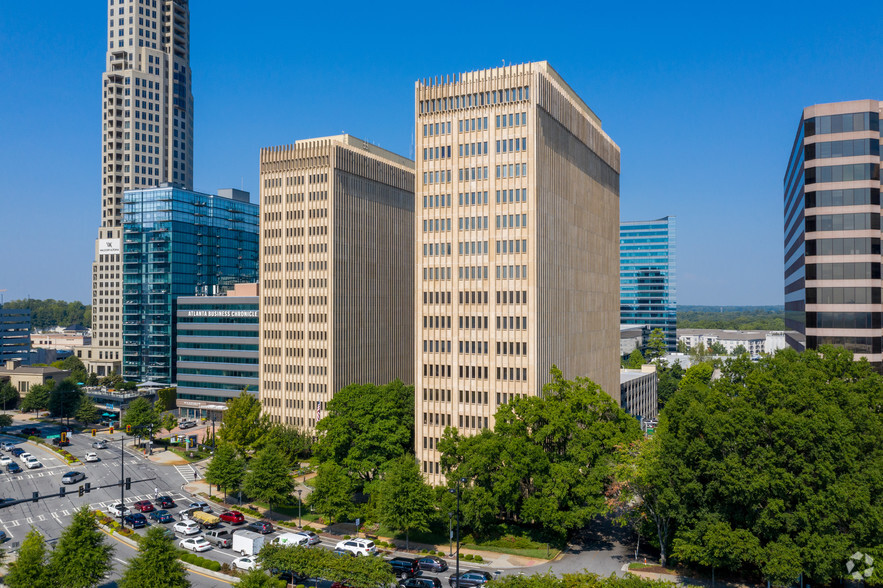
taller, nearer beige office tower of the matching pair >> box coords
[415,62,620,483]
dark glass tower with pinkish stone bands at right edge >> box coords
[784,100,883,363]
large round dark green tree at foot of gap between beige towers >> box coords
[314,380,414,482]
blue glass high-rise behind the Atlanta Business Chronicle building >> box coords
[123,186,259,384]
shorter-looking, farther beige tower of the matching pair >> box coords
[260,135,414,430]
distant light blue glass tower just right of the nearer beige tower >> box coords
[619,216,678,351]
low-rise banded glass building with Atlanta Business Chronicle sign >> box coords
[175,296,260,417]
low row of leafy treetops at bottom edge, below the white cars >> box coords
[258,544,395,588]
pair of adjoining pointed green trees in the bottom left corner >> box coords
[3,507,113,588]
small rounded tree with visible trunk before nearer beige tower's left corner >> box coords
[378,455,435,549]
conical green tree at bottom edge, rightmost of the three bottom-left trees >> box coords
[119,527,190,588]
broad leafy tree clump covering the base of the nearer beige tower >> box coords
[438,367,641,537]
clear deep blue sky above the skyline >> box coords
[0,0,883,305]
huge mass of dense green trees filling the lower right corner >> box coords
[623,346,883,585]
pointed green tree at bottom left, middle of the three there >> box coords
[49,506,113,588]
